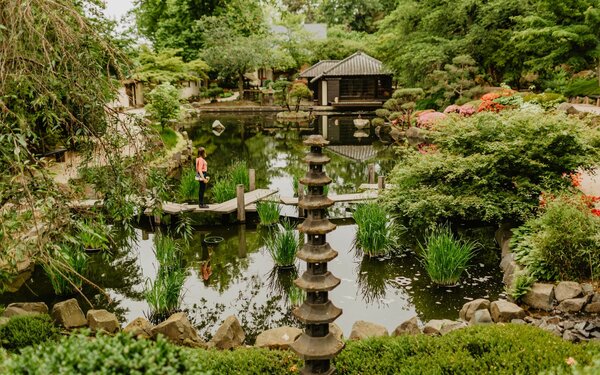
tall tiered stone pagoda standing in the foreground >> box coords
[292,135,344,374]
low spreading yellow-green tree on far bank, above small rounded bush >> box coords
[132,45,210,84]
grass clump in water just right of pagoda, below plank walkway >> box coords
[353,203,398,257]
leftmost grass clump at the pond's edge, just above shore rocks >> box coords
[42,244,89,295]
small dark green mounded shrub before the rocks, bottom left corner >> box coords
[0,314,59,351]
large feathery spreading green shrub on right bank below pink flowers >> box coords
[384,111,600,227]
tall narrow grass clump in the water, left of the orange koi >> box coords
[144,234,186,324]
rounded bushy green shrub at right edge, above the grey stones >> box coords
[511,195,600,280]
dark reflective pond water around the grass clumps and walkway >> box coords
[0,114,503,335]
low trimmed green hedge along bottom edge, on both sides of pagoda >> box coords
[0,324,600,375]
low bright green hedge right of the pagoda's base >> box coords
[335,324,600,375]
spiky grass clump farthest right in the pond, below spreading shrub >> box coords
[419,226,477,285]
